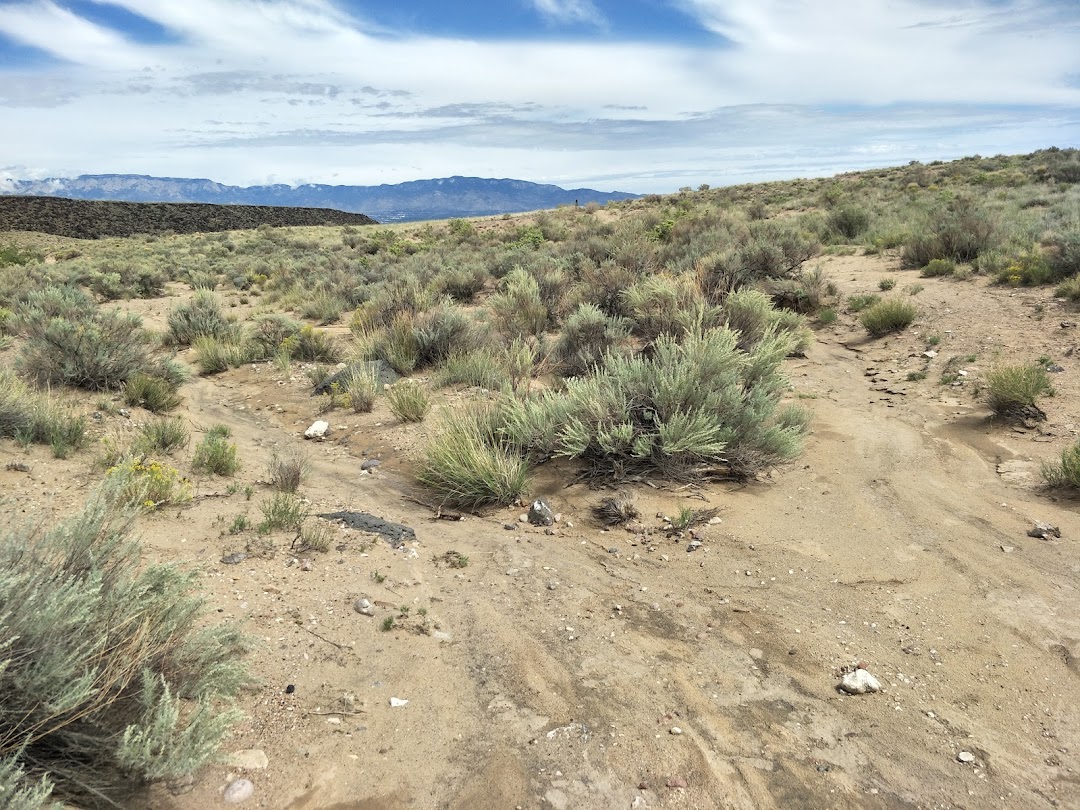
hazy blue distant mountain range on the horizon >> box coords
[0,174,639,222]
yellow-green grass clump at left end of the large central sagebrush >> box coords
[417,406,529,508]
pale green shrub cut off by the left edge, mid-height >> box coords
[0,367,89,458]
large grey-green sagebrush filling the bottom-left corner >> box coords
[0,480,248,810]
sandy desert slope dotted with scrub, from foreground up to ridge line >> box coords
[0,149,1080,810]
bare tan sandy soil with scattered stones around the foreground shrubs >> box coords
[0,252,1080,810]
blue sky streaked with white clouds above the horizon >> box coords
[0,0,1080,192]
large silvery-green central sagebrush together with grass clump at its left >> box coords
[418,328,810,505]
